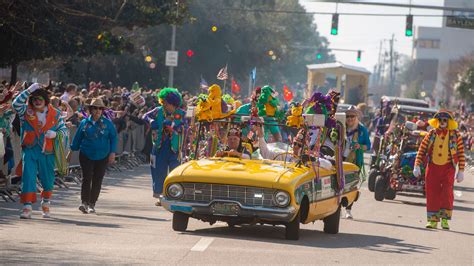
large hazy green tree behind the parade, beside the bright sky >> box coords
[58,0,334,91]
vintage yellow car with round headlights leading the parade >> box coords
[161,153,360,240]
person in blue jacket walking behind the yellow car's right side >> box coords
[343,105,370,219]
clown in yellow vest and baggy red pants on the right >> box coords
[413,110,465,230]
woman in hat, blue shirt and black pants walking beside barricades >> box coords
[67,98,117,213]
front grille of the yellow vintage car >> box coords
[182,183,275,207]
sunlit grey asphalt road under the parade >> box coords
[0,162,474,265]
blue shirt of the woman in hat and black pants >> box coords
[71,117,117,161]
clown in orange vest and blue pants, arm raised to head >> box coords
[12,83,67,219]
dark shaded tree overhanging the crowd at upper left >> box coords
[0,0,187,82]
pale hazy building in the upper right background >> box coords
[413,0,474,106]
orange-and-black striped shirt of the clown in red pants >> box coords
[415,129,466,171]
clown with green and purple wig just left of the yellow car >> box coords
[143,88,184,206]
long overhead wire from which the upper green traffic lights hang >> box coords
[211,8,450,17]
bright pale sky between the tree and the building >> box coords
[299,0,444,72]
